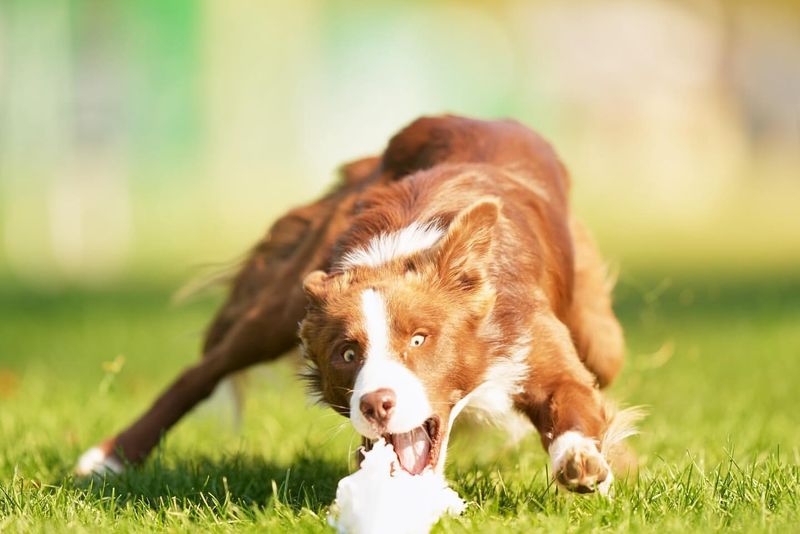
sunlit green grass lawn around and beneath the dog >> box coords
[0,276,800,532]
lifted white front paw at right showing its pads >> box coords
[548,432,614,495]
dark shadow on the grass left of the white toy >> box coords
[66,454,348,512]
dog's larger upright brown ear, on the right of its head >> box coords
[437,199,500,290]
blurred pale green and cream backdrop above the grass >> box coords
[0,0,800,290]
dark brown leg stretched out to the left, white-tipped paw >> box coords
[76,161,380,474]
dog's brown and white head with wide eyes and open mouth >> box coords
[300,201,499,473]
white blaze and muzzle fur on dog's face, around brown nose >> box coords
[350,289,433,439]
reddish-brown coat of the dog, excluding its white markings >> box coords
[86,116,623,490]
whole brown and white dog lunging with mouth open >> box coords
[77,116,629,493]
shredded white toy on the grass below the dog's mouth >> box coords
[328,438,466,534]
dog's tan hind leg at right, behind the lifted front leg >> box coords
[567,217,625,387]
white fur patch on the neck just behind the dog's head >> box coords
[339,222,444,269]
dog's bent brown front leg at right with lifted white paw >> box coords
[517,314,613,495]
